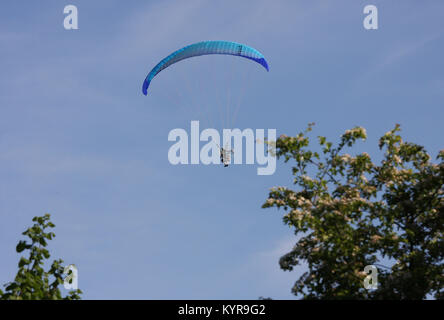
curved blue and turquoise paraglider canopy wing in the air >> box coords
[142,41,268,95]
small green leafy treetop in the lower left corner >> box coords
[0,214,82,300]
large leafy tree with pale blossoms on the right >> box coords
[263,124,444,299]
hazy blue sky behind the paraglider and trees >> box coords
[0,0,444,299]
